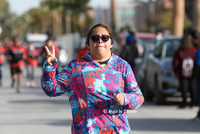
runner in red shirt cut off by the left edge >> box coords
[0,42,6,86]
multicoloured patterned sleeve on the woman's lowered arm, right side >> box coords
[123,65,144,109]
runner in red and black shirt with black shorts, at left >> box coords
[8,36,27,93]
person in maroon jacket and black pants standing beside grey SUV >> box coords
[173,35,197,108]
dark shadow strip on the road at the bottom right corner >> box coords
[129,118,200,132]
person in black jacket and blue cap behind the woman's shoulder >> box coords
[120,32,138,70]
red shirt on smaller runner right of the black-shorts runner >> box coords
[26,48,40,67]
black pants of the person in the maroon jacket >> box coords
[179,78,196,106]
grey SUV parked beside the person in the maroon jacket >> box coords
[142,36,181,104]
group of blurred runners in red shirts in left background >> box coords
[0,36,59,93]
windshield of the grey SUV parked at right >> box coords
[162,39,180,57]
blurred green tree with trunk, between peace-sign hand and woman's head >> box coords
[41,0,89,33]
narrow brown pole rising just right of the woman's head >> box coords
[111,0,116,37]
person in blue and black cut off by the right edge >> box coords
[192,34,200,122]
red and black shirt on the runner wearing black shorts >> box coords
[9,45,26,68]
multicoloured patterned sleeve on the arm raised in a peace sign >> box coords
[41,60,71,97]
